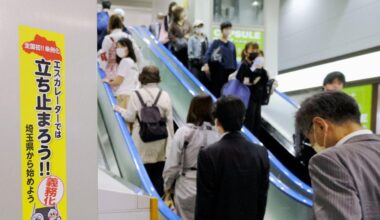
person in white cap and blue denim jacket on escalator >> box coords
[187,20,209,87]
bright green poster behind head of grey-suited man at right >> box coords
[343,84,372,129]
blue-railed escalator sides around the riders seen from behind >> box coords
[98,24,312,219]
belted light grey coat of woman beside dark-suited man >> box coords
[163,122,220,220]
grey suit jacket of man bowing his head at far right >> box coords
[309,134,380,220]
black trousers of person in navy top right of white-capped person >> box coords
[209,63,235,98]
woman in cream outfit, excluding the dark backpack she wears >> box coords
[115,66,174,195]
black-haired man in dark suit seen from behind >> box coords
[195,96,269,220]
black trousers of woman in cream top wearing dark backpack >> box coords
[144,161,165,197]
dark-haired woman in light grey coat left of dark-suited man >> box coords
[163,94,219,220]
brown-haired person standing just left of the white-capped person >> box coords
[169,6,192,67]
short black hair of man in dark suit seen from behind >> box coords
[213,96,245,132]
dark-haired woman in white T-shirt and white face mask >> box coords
[104,38,139,108]
